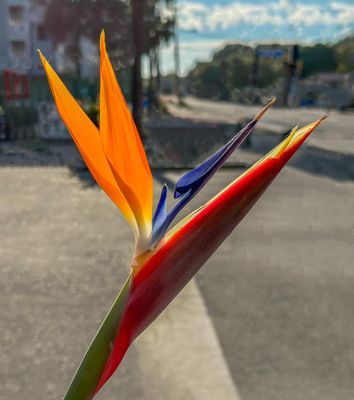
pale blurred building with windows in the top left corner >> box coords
[0,0,54,75]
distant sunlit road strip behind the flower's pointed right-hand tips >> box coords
[164,97,354,154]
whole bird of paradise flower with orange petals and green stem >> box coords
[40,33,325,400]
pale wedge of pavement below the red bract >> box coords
[135,279,240,400]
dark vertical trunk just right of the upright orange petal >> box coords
[132,0,144,136]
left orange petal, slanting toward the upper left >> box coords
[39,52,137,234]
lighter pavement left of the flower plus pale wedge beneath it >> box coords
[0,143,238,400]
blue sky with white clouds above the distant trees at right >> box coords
[161,0,354,75]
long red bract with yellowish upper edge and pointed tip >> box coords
[97,121,319,390]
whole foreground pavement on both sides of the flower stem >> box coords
[0,138,354,400]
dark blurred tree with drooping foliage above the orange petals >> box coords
[46,0,174,128]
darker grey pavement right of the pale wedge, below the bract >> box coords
[162,138,354,400]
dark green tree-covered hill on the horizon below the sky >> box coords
[187,35,354,100]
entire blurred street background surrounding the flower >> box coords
[0,0,354,400]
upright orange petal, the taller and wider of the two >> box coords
[100,32,153,238]
